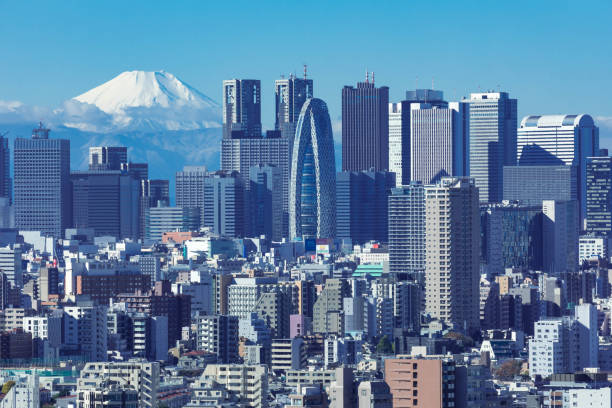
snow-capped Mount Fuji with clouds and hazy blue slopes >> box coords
[0,71,222,181]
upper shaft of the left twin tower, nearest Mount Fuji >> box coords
[223,79,261,139]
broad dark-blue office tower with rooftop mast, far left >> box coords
[14,124,72,238]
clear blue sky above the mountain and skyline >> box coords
[0,0,612,137]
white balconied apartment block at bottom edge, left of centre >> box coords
[203,364,268,408]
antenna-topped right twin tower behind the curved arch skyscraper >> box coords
[274,74,313,141]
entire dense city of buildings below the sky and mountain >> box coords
[0,67,612,408]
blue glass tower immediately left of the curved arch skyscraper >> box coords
[248,165,283,241]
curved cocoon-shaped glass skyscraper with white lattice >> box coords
[289,98,336,239]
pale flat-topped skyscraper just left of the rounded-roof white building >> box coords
[465,92,517,202]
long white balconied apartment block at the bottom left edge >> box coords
[77,360,160,408]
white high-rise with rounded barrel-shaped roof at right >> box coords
[517,114,599,228]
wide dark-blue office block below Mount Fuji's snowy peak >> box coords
[70,170,140,239]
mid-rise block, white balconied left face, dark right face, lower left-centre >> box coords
[196,315,238,364]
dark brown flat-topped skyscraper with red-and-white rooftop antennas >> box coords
[342,74,389,171]
